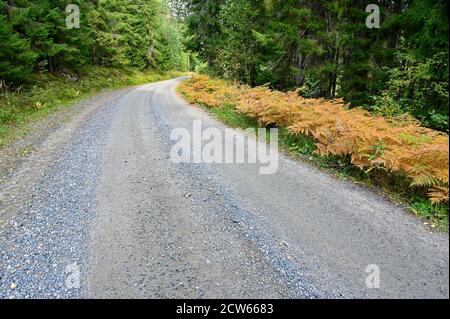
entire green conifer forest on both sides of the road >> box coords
[0,0,448,131]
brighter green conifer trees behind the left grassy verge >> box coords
[0,0,184,85]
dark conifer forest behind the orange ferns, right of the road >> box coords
[176,0,448,131]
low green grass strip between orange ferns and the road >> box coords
[178,80,449,231]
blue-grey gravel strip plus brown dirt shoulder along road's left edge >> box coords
[0,89,129,298]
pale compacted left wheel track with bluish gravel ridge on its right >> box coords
[87,85,318,298]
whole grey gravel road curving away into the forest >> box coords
[0,78,449,298]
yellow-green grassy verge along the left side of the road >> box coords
[0,67,185,149]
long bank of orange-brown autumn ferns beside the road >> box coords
[181,75,449,203]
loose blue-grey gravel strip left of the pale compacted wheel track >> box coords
[0,96,122,298]
